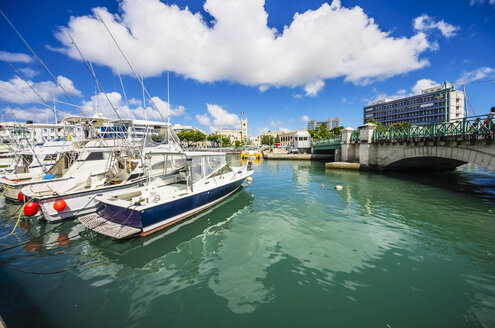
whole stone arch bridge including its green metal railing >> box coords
[313,115,495,170]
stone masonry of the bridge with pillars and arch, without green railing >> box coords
[340,123,495,170]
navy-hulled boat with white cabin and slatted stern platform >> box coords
[79,152,253,239]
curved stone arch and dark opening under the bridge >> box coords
[378,146,495,170]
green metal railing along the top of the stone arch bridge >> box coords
[373,115,495,141]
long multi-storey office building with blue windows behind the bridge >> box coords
[363,83,465,126]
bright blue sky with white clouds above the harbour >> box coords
[0,0,495,136]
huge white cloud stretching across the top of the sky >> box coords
[56,0,432,88]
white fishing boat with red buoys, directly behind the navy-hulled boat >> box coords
[21,125,185,222]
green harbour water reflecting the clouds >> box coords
[0,156,495,328]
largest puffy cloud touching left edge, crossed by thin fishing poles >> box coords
[0,75,81,104]
